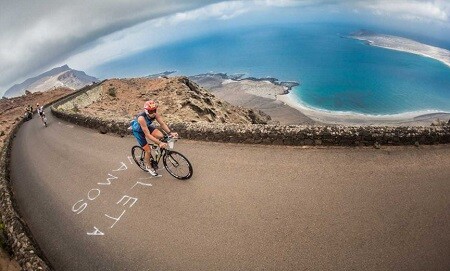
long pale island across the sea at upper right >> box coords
[348,30,450,67]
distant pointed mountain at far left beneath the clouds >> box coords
[4,65,99,98]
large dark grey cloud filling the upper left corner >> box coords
[0,0,218,91]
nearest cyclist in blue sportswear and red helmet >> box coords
[131,100,178,176]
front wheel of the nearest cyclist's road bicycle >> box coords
[163,151,193,180]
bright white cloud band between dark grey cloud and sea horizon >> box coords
[65,1,249,72]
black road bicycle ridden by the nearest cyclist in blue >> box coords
[131,135,193,180]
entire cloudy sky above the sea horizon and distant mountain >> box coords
[0,0,450,97]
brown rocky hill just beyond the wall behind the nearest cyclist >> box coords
[76,77,270,124]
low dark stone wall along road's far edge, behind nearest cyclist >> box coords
[52,106,450,147]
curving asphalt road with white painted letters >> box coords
[11,109,450,271]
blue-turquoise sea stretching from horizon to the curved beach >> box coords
[95,24,450,119]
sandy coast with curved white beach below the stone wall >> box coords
[182,73,450,126]
